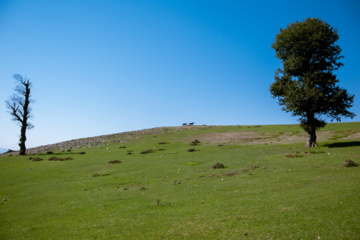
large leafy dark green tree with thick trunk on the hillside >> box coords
[270,18,355,147]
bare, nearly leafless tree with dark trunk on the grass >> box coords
[5,74,34,155]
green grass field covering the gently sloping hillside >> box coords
[0,122,360,239]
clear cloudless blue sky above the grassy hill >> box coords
[0,0,360,149]
